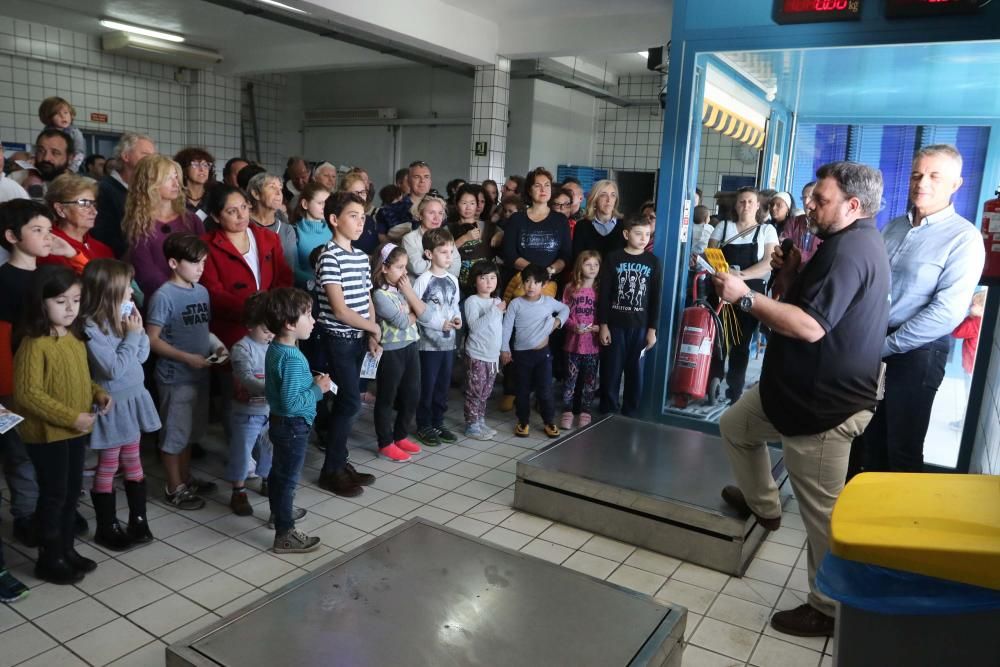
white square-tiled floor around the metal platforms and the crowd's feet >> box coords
[0,394,832,667]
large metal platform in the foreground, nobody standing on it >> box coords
[167,519,687,667]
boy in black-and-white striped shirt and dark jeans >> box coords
[316,192,382,497]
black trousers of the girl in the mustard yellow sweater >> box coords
[27,436,87,549]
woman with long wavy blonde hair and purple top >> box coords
[122,155,205,298]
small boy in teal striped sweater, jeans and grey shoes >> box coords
[264,287,336,554]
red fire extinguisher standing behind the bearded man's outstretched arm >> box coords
[670,271,722,408]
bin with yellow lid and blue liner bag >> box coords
[816,473,1000,667]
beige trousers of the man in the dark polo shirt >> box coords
[719,387,872,616]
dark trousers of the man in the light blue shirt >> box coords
[851,343,948,473]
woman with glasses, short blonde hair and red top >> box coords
[38,174,115,274]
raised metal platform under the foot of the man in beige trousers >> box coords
[514,416,790,576]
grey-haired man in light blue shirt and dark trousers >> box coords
[850,144,986,474]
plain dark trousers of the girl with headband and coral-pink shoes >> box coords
[375,343,420,449]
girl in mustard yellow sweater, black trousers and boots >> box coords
[14,266,111,584]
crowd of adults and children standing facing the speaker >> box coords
[0,98,660,601]
